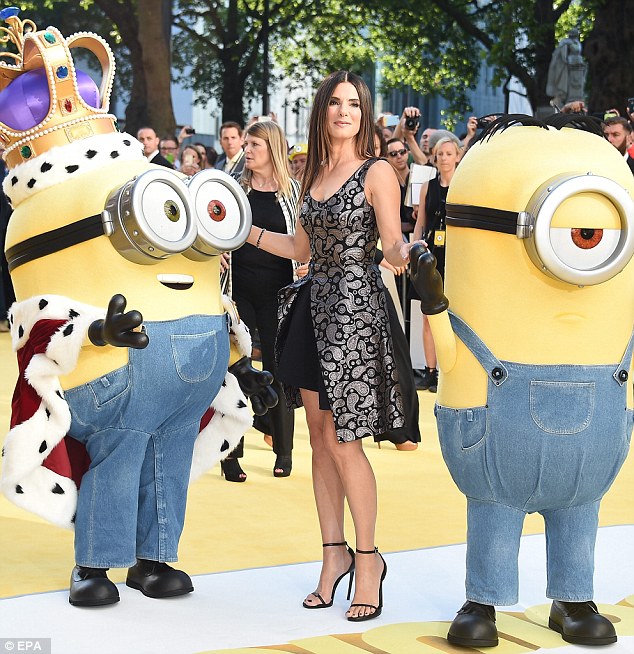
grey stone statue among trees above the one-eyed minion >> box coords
[546,29,587,107]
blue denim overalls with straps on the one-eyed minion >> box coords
[435,314,634,605]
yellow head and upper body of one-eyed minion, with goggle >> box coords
[432,116,634,406]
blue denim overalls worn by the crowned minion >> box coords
[65,316,229,568]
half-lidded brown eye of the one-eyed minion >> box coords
[550,227,621,270]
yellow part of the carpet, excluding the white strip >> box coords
[0,334,634,597]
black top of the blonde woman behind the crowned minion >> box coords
[231,190,293,289]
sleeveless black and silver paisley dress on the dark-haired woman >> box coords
[276,159,405,442]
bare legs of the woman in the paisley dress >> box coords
[302,389,383,617]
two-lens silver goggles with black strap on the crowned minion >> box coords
[6,168,251,271]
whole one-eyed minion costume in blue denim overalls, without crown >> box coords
[411,114,634,648]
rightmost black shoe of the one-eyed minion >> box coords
[548,600,616,645]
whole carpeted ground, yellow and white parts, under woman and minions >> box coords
[0,334,634,654]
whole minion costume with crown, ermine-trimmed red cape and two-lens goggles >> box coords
[0,8,277,606]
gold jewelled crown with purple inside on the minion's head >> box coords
[0,7,117,168]
